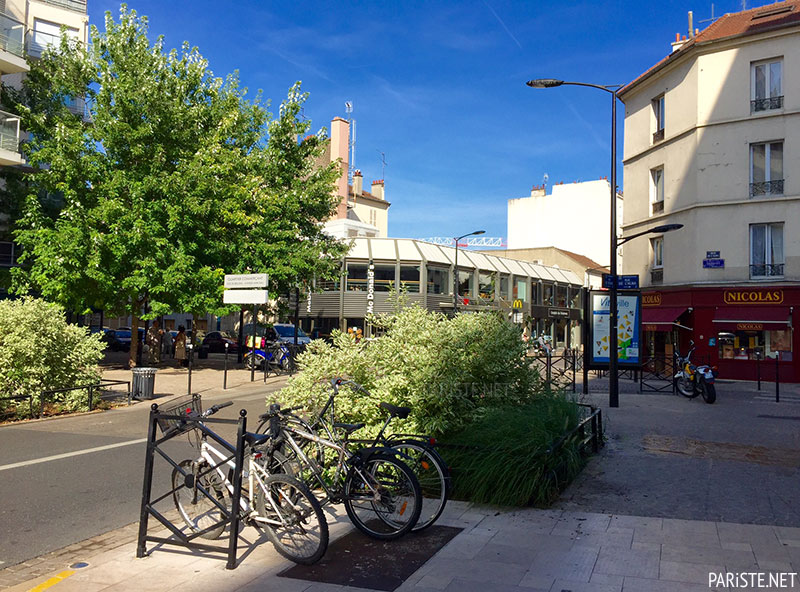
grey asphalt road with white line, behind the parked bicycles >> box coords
[0,385,282,568]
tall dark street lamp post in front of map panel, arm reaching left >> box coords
[525,78,622,407]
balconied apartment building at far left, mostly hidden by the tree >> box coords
[0,0,89,269]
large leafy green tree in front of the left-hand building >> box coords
[6,5,343,363]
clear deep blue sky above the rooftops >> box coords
[89,0,767,237]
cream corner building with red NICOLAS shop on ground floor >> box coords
[619,0,800,381]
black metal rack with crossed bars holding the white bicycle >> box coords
[136,403,247,569]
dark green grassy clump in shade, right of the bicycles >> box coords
[439,396,582,506]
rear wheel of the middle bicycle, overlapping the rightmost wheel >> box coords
[343,454,422,540]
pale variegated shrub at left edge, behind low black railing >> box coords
[0,297,103,415]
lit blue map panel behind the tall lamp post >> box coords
[586,291,642,369]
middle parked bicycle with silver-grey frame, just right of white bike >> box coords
[259,404,422,540]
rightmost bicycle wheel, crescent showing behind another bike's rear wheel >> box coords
[391,441,450,532]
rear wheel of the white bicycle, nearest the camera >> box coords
[255,474,328,565]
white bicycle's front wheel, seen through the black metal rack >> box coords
[172,459,231,539]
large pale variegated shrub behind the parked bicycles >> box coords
[275,305,543,435]
